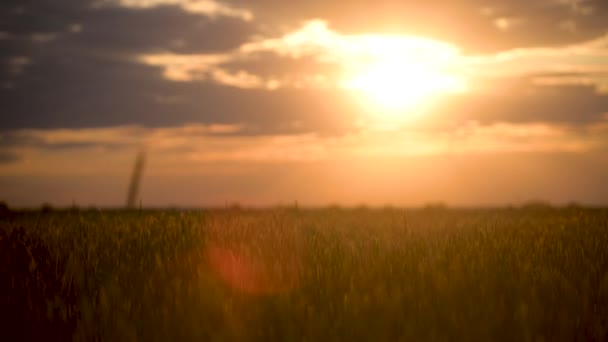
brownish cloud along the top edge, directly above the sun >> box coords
[227,0,608,52]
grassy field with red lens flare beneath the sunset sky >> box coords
[0,208,608,341]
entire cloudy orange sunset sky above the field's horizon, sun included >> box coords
[0,0,608,207]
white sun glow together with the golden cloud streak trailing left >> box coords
[141,19,470,127]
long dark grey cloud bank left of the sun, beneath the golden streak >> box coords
[0,50,355,134]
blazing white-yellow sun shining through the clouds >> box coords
[341,36,466,121]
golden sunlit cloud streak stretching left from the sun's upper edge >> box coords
[139,20,459,89]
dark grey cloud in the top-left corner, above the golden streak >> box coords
[0,0,255,55]
